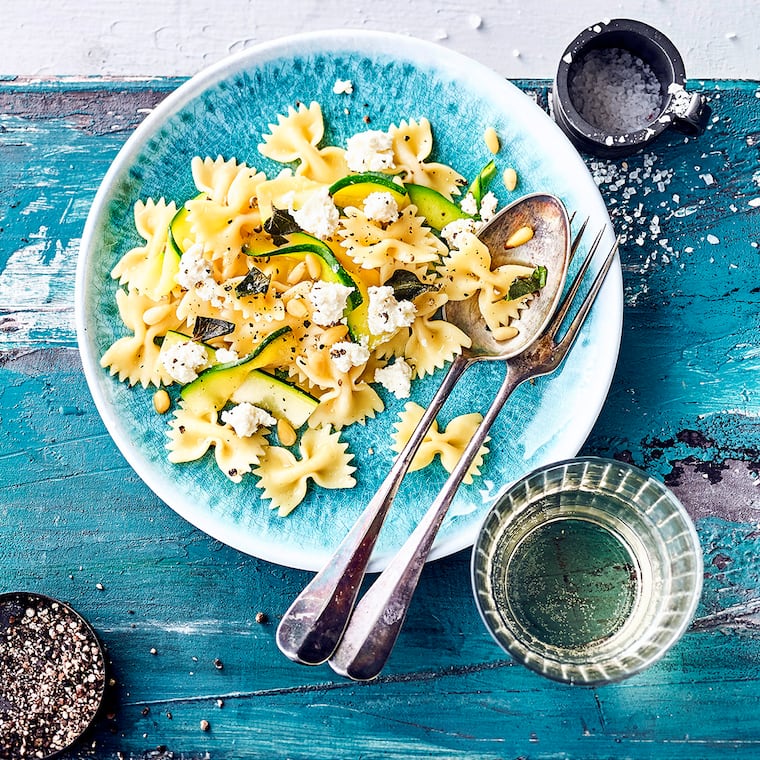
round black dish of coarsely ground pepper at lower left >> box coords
[0,592,106,760]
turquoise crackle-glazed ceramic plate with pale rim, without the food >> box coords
[77,31,622,569]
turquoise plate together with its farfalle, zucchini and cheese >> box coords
[76,31,622,570]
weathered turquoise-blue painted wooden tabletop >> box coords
[0,80,760,760]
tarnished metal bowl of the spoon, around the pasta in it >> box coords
[444,193,570,361]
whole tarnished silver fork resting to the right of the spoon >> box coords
[328,230,618,681]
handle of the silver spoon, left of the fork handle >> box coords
[277,355,470,665]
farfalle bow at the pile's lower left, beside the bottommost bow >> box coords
[167,402,268,483]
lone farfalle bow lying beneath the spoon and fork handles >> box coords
[391,401,490,484]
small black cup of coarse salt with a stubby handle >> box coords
[551,19,711,158]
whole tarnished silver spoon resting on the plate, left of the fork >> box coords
[277,193,570,665]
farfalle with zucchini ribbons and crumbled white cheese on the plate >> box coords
[101,98,544,515]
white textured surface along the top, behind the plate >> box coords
[0,0,760,79]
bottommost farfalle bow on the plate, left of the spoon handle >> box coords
[253,425,356,517]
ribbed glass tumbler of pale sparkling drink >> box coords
[472,457,703,685]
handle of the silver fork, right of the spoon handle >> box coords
[329,368,528,681]
